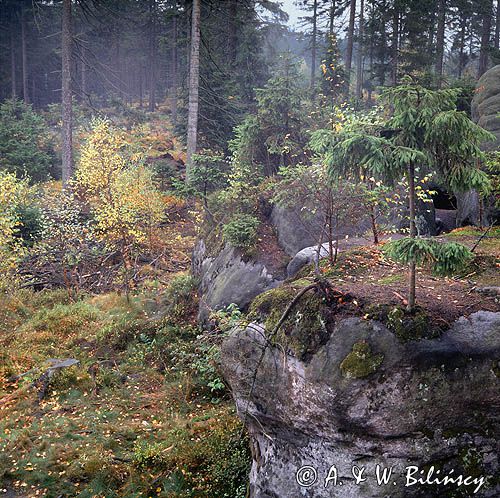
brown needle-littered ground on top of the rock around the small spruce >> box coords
[296,227,500,328]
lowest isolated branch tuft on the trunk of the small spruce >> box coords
[383,237,473,275]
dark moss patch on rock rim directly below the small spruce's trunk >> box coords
[364,304,443,342]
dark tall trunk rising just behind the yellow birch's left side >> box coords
[62,0,73,187]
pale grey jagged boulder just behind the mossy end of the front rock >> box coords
[192,240,282,322]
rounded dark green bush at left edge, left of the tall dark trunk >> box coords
[0,100,54,181]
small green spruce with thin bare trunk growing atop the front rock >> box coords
[316,79,491,311]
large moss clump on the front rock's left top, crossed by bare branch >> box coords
[249,280,331,360]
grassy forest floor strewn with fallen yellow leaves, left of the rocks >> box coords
[0,203,250,498]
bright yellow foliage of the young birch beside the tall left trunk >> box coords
[74,119,165,246]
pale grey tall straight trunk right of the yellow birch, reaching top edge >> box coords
[186,0,201,180]
